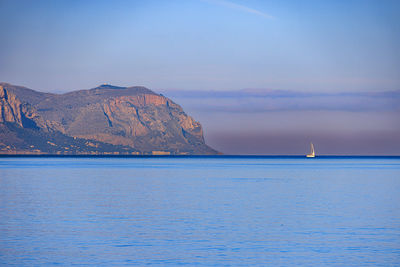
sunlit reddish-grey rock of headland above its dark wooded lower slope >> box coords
[0,84,217,154]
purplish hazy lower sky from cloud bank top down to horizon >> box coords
[163,89,400,155]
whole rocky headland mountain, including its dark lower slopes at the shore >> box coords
[0,83,218,154]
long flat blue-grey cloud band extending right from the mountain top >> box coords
[159,89,400,113]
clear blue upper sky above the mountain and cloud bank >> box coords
[0,0,400,91]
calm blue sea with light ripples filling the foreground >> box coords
[0,157,400,266]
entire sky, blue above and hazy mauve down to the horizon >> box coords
[0,0,400,155]
